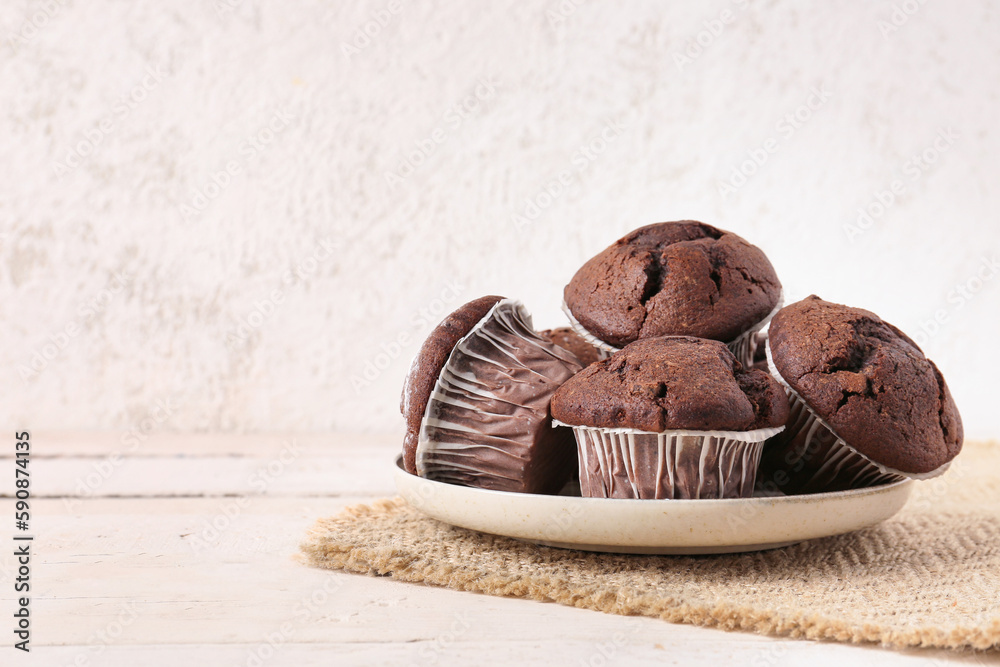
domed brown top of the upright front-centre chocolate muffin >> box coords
[552,336,788,432]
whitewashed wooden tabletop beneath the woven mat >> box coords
[0,431,998,667]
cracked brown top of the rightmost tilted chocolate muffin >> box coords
[768,295,963,474]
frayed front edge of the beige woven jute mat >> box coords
[302,497,1000,649]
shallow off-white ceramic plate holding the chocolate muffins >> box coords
[394,457,913,554]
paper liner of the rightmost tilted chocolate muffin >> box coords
[757,343,948,494]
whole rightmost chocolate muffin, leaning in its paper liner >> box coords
[759,296,963,494]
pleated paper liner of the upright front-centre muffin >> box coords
[554,422,784,499]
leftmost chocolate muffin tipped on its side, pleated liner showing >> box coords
[401,296,582,493]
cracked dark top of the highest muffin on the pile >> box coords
[563,220,781,347]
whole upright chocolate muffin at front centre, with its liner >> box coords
[552,336,788,498]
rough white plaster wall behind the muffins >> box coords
[0,0,1000,436]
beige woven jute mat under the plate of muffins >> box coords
[302,442,1000,653]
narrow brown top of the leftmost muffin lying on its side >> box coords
[399,296,503,475]
